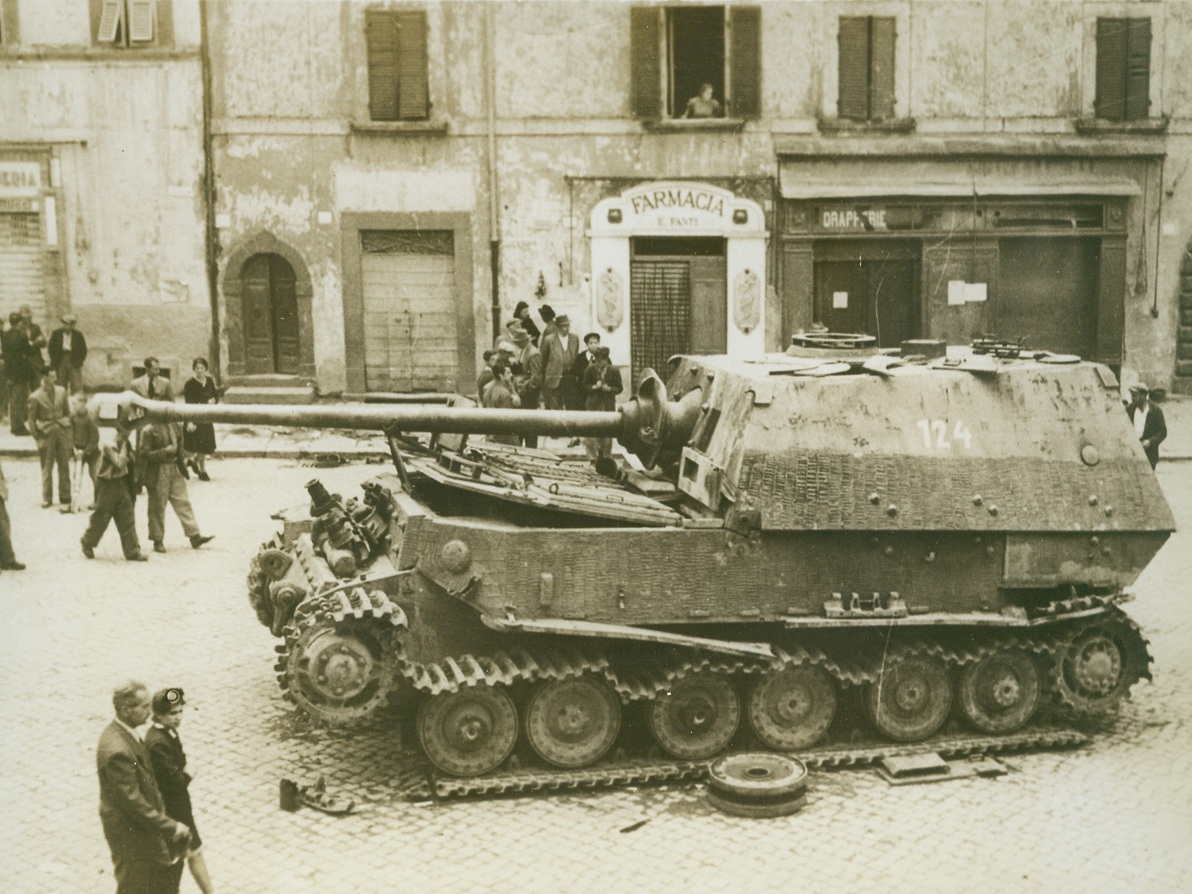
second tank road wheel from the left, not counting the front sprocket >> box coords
[526,675,621,770]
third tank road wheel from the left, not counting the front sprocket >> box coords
[647,673,741,760]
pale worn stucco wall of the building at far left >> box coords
[0,0,211,387]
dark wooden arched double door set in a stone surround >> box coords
[241,254,299,375]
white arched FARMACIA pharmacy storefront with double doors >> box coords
[589,182,768,378]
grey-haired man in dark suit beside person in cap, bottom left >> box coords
[95,681,191,894]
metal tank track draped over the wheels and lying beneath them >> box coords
[277,603,1150,799]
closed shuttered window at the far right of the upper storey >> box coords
[1097,18,1150,122]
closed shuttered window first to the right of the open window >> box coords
[837,15,894,122]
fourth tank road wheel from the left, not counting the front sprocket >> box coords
[746,665,836,751]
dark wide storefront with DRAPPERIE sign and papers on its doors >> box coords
[781,150,1146,366]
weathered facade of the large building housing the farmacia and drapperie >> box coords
[0,0,1192,395]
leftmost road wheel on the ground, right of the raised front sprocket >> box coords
[417,687,517,776]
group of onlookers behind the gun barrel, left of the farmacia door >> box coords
[476,302,623,462]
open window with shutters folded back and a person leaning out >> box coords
[629,6,762,119]
